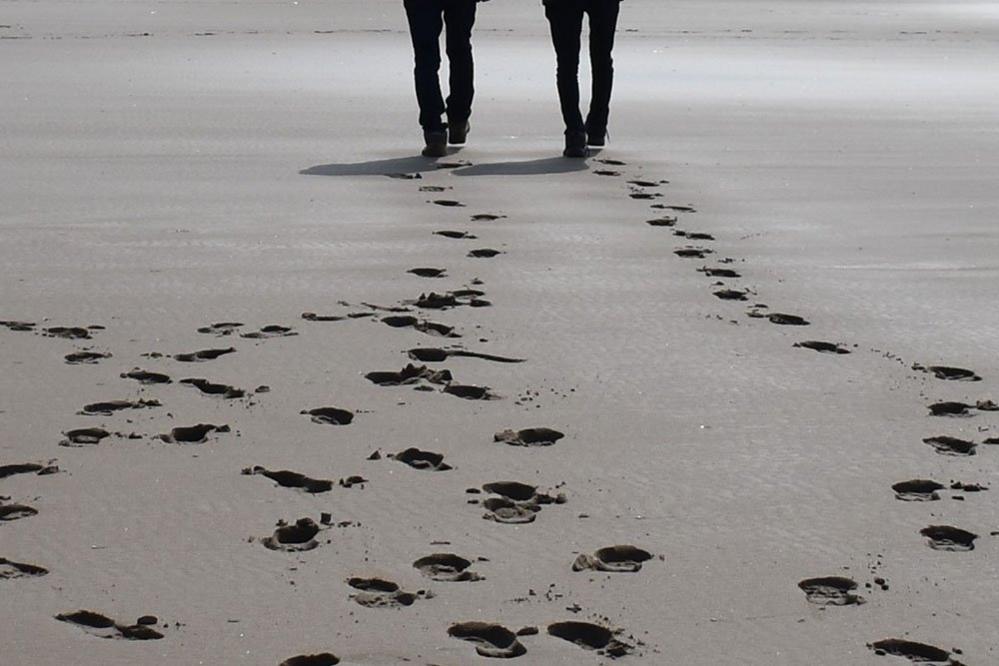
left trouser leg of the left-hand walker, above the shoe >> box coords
[404,0,444,132]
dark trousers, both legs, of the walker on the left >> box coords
[404,0,476,131]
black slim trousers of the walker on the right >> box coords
[545,0,621,134]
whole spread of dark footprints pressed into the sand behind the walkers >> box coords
[0,159,999,666]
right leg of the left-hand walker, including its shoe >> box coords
[444,0,477,137]
